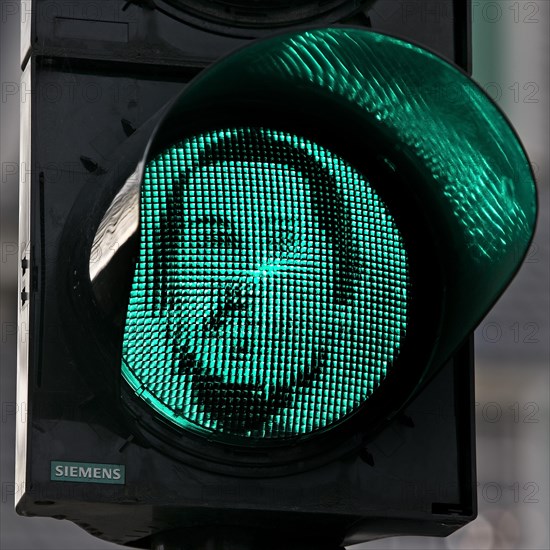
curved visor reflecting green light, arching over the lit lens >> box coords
[177,27,537,374]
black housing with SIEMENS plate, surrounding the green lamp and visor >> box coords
[16,0,476,550]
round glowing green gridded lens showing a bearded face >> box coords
[122,128,410,444]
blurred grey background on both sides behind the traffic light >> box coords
[0,0,550,550]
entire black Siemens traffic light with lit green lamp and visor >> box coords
[17,1,536,549]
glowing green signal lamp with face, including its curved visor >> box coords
[118,28,536,444]
